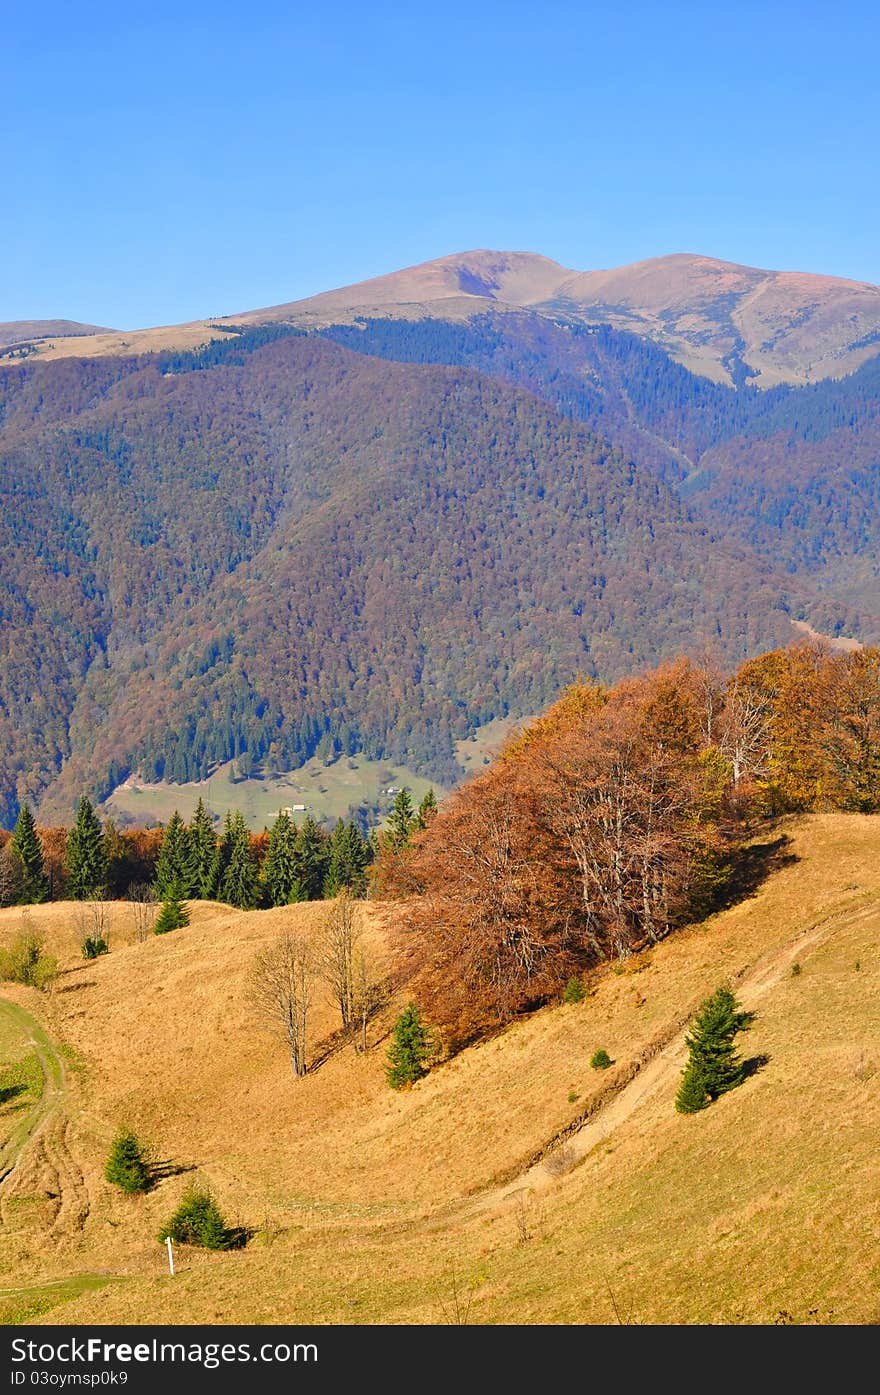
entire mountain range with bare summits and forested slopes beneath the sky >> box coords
[0,252,880,822]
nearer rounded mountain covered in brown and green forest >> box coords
[0,326,859,822]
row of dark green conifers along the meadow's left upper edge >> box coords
[0,790,437,909]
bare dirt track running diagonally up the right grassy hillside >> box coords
[456,903,877,1216]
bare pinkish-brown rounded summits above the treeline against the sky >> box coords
[249,251,880,386]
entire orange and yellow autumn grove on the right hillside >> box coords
[374,644,880,1043]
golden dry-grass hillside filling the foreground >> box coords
[0,815,880,1322]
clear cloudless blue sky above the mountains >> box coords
[6,0,880,328]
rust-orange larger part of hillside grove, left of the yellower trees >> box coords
[379,661,731,1043]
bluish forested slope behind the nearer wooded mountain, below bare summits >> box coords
[322,311,880,611]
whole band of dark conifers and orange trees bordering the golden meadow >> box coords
[0,643,880,1045]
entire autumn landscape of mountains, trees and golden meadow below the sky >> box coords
[0,252,880,1325]
